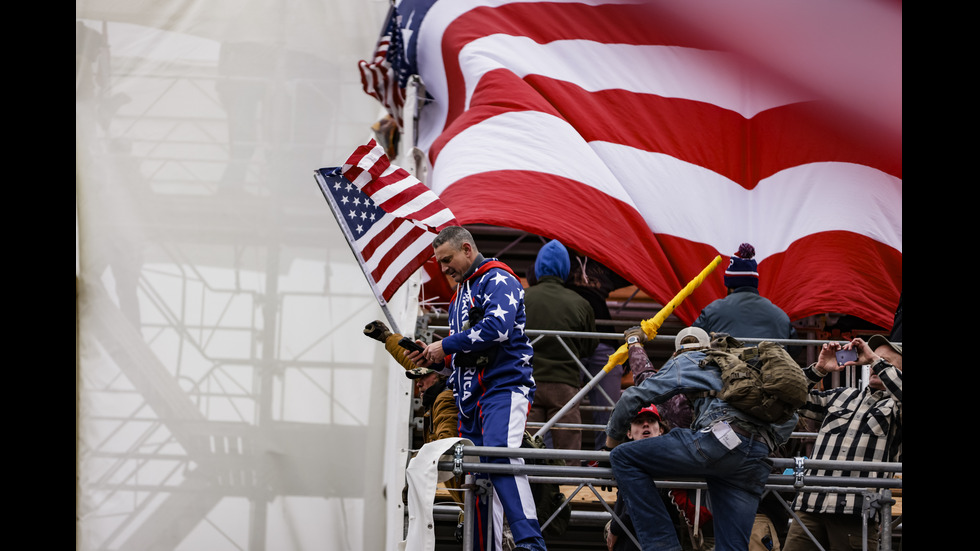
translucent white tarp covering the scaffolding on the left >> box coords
[75,0,417,551]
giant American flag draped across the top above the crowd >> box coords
[364,0,902,327]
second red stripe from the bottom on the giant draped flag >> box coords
[430,69,902,189]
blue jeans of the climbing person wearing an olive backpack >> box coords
[609,429,771,551]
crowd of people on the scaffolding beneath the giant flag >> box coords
[364,226,902,551]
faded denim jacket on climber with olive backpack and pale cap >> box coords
[606,350,797,450]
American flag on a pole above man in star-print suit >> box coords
[315,140,457,305]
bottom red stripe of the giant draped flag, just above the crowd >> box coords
[443,171,902,327]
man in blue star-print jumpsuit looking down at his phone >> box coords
[422,226,546,551]
